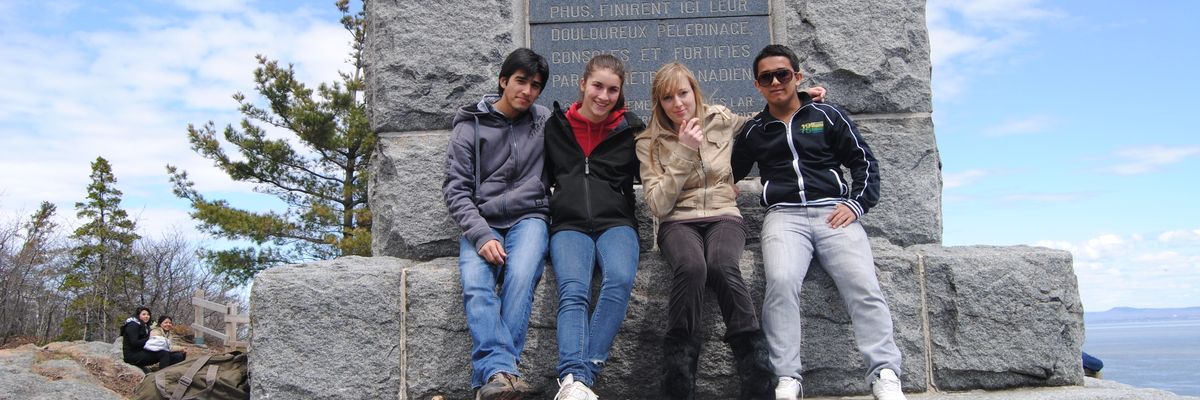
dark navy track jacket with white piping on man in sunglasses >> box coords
[731,91,880,216]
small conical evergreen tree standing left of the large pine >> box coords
[62,157,140,341]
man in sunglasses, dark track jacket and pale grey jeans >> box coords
[731,44,905,400]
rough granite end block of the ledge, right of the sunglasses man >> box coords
[910,245,1084,390]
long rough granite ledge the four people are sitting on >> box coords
[258,238,1084,399]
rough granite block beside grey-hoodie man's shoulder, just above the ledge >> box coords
[367,131,462,259]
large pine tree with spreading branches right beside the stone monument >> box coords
[167,0,376,285]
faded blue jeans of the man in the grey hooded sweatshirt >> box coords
[458,219,548,388]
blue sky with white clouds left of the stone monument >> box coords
[0,1,350,234]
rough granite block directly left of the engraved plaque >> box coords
[364,0,526,132]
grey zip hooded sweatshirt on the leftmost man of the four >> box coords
[442,95,550,251]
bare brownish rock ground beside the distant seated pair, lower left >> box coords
[0,333,236,400]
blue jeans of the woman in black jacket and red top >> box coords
[550,226,641,387]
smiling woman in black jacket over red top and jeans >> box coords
[545,54,646,400]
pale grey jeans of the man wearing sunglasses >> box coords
[762,207,900,386]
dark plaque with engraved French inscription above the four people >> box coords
[529,0,770,115]
